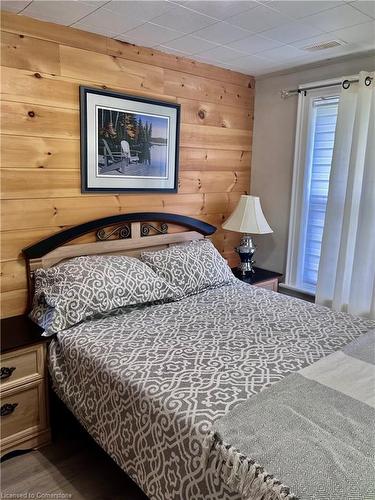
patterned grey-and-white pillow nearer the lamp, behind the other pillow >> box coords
[141,239,236,298]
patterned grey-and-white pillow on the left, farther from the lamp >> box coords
[30,255,176,334]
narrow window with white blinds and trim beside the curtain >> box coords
[286,87,339,294]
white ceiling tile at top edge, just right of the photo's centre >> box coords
[183,0,259,21]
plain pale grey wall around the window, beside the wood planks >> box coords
[251,55,375,273]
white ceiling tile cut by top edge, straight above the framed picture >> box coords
[105,0,175,21]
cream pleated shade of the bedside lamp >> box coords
[222,195,273,234]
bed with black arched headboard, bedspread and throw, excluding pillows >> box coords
[24,213,375,500]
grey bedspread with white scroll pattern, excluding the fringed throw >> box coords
[49,281,375,500]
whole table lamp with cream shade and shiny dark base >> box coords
[222,195,273,275]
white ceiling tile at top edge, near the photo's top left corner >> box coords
[22,0,97,26]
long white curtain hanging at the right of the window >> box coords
[316,72,375,318]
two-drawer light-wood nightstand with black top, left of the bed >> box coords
[0,316,51,457]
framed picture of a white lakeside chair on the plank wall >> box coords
[80,87,180,193]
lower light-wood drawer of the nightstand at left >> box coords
[0,379,47,451]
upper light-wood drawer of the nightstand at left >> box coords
[0,344,45,391]
